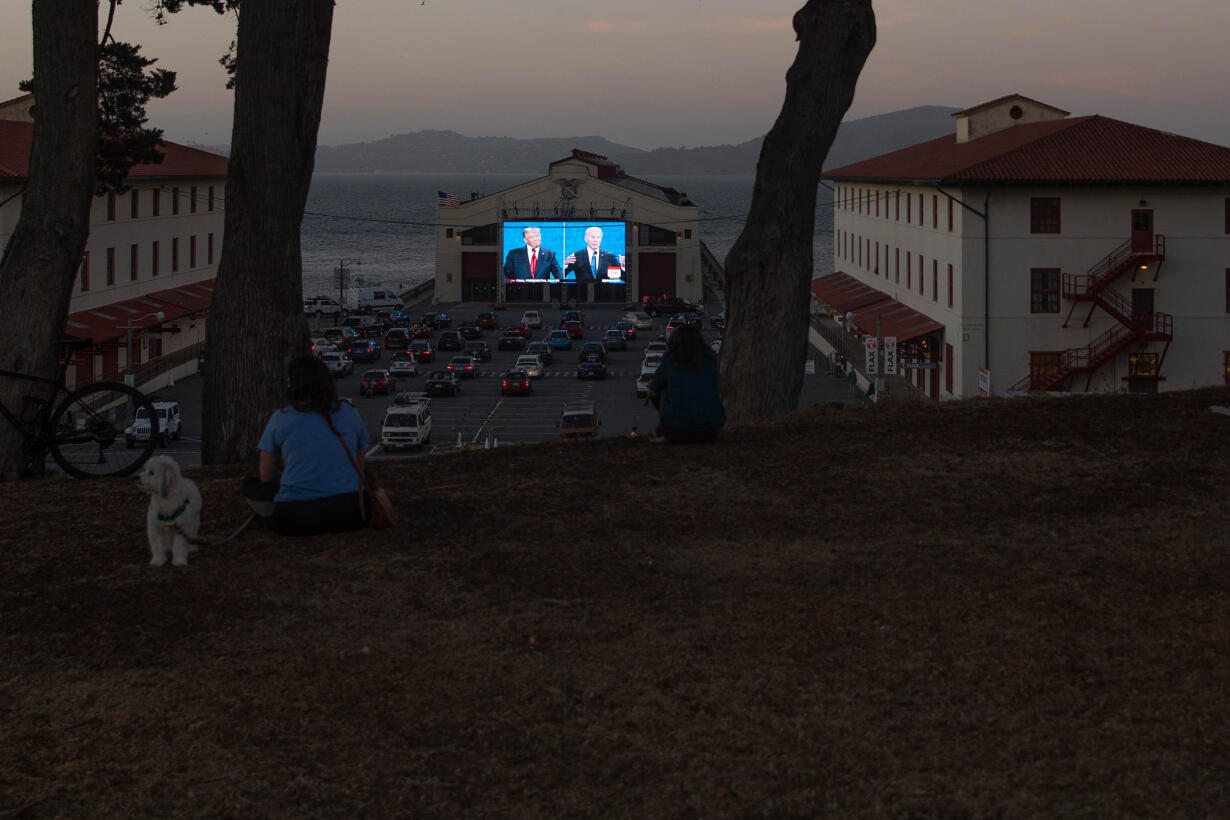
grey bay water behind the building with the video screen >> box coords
[300,173,833,298]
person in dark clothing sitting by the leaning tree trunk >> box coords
[647,325,726,444]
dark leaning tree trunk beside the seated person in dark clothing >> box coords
[722,0,876,420]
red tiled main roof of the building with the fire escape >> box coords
[820,116,1230,184]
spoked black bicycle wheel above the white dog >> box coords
[44,381,157,478]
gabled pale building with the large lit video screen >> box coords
[435,150,702,302]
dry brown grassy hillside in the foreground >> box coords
[0,390,1230,818]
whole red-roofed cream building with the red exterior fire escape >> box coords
[813,95,1230,398]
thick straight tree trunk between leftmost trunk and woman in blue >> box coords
[202,0,333,463]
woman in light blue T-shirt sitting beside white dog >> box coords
[244,357,371,535]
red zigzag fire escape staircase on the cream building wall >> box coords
[1012,234,1173,390]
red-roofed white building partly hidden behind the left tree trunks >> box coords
[0,95,228,388]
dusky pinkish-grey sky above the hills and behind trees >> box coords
[0,0,1230,149]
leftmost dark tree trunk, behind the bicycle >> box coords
[0,0,98,481]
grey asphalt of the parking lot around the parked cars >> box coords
[146,304,847,467]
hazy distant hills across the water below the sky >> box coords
[194,106,959,177]
